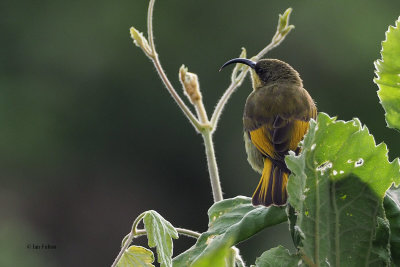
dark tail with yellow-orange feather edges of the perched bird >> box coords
[252,158,289,207]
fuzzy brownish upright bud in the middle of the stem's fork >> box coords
[179,65,202,105]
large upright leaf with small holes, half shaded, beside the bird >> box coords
[286,113,400,266]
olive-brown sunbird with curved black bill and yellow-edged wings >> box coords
[220,58,317,207]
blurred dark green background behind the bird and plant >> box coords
[0,0,400,266]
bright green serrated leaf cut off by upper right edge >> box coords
[374,17,400,130]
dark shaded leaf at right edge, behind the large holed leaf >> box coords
[383,187,400,266]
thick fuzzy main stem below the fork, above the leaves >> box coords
[202,128,223,202]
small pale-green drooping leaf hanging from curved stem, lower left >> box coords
[143,210,178,267]
